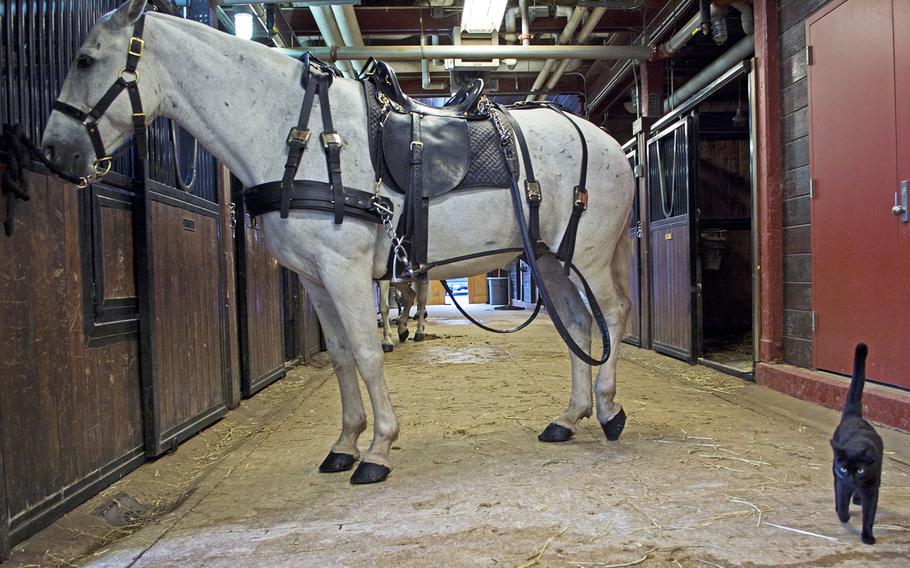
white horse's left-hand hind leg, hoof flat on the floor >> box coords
[537,255,592,442]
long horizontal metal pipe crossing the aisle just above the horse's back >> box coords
[275,45,651,61]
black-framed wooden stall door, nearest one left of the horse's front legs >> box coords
[137,180,230,455]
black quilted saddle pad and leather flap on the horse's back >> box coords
[364,81,517,196]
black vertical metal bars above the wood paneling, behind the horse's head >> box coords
[0,0,218,202]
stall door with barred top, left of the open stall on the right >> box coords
[648,117,697,362]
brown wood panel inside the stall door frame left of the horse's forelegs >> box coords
[150,201,226,437]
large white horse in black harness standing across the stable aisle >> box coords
[43,0,634,483]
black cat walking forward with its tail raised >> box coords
[831,343,885,544]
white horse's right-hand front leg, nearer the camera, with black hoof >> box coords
[320,263,398,484]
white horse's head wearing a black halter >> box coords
[42,0,161,177]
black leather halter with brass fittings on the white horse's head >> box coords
[53,14,148,187]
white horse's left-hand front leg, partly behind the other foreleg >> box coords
[301,279,367,473]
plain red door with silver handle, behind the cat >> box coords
[807,0,910,387]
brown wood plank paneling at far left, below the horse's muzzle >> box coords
[0,174,143,552]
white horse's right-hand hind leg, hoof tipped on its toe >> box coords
[589,235,632,442]
